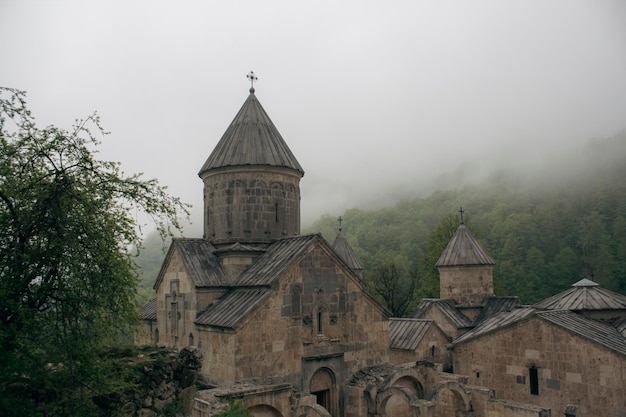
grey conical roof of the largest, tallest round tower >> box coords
[199,91,304,176]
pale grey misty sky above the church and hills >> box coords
[0,0,626,229]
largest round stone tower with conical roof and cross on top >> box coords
[198,72,304,246]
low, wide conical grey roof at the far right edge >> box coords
[535,279,626,311]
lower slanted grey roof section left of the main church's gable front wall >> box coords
[196,288,272,329]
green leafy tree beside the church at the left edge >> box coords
[0,88,187,416]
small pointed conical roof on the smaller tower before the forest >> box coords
[435,223,496,267]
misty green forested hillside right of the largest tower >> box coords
[305,132,626,314]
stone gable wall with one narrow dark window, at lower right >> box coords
[454,317,626,417]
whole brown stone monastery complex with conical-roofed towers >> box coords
[135,83,626,417]
